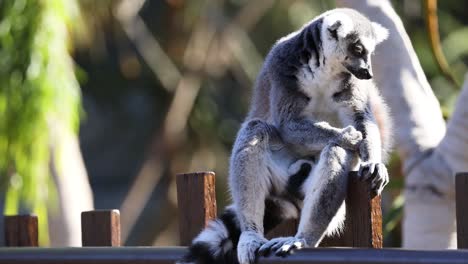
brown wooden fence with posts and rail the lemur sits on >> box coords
[0,172,468,264]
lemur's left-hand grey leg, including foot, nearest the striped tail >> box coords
[229,119,287,264]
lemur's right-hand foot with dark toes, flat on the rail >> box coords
[258,237,307,257]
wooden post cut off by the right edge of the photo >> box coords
[455,172,468,249]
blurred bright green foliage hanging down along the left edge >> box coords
[0,0,80,243]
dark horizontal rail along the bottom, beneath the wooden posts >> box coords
[0,247,468,264]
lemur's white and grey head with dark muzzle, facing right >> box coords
[321,8,388,80]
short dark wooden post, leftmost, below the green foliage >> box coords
[5,215,38,247]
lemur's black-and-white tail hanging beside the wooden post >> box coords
[178,207,240,264]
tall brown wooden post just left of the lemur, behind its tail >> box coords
[176,172,216,246]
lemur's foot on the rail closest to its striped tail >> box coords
[237,231,268,264]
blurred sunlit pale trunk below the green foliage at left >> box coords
[49,124,93,247]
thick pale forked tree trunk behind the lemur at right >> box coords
[337,0,468,249]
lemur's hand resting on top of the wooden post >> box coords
[358,162,389,195]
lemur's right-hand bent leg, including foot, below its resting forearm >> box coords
[259,144,357,255]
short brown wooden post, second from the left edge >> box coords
[81,209,120,247]
